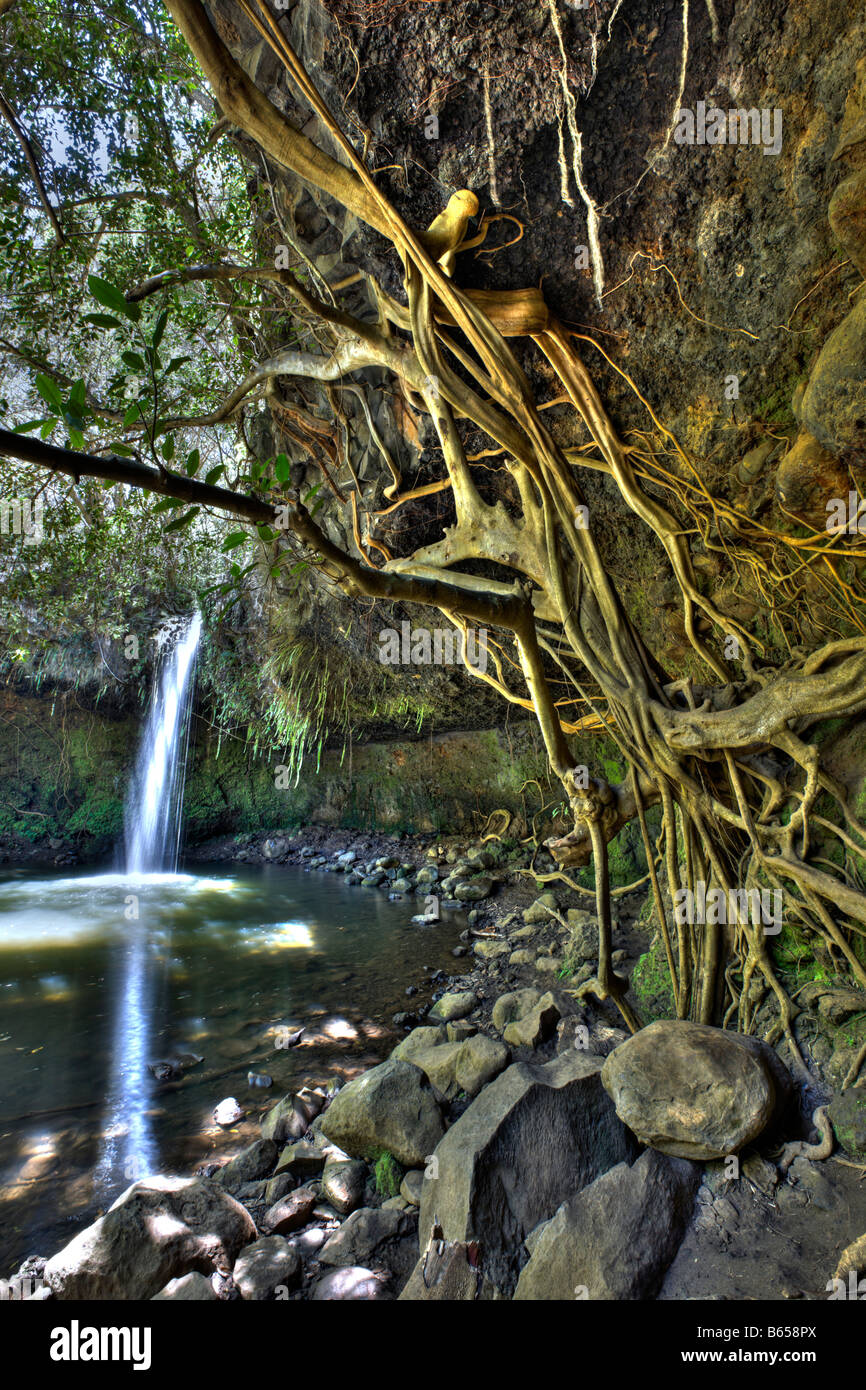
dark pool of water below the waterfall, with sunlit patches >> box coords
[0,865,466,1276]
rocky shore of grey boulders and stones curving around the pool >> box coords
[8,827,866,1301]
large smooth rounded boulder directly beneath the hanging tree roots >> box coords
[602,1019,781,1159]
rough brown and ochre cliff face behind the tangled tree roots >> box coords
[211,0,866,667]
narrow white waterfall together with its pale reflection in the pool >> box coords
[96,613,202,1187]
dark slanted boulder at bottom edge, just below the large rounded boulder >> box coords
[514,1150,701,1301]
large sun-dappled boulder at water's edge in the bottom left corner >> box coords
[43,1176,256,1301]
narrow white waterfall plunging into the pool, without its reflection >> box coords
[124,613,202,873]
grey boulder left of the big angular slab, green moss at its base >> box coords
[321,1058,443,1168]
